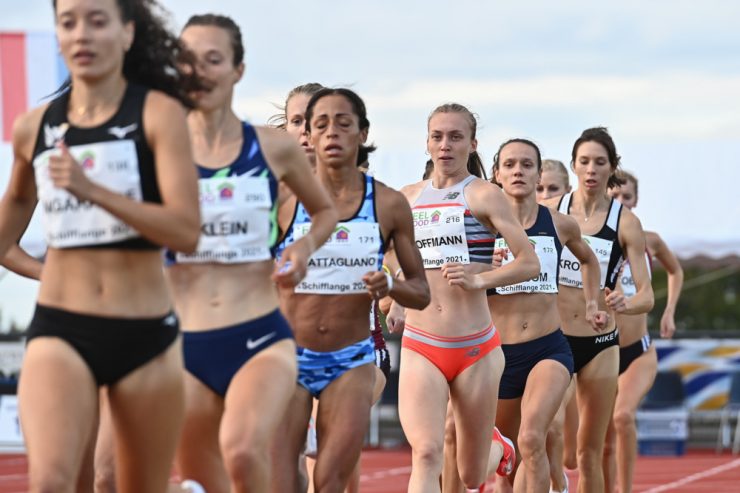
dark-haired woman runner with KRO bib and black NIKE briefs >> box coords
[550,128,653,493]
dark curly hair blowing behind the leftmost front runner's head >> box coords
[52,0,203,108]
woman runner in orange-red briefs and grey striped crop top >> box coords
[389,104,539,492]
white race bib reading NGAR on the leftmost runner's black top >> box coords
[33,140,142,248]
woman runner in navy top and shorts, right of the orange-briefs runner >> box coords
[488,139,606,492]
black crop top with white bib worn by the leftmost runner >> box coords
[33,84,162,249]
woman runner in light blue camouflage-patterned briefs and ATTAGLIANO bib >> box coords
[273,89,429,493]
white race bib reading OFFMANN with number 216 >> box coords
[412,205,470,269]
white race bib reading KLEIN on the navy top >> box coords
[176,175,272,264]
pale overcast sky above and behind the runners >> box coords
[0,0,740,328]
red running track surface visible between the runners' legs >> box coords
[0,449,740,493]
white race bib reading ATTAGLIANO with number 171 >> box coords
[293,222,380,294]
